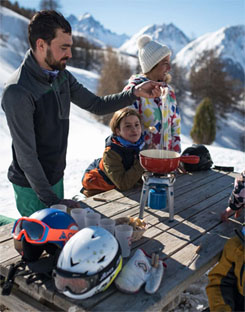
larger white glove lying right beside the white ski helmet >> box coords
[115,249,151,294]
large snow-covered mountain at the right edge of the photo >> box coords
[174,25,245,81]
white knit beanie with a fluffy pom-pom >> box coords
[137,35,171,74]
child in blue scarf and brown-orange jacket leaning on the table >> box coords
[81,107,144,197]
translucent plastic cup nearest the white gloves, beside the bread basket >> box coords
[115,224,133,258]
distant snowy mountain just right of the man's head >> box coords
[67,13,129,48]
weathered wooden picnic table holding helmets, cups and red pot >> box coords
[0,170,244,311]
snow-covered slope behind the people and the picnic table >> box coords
[0,6,245,218]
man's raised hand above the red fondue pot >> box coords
[134,80,163,98]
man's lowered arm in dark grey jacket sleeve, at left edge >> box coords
[2,85,60,207]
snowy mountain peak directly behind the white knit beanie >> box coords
[119,23,190,56]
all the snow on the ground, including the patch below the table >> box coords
[0,7,245,312]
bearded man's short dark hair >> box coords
[28,10,71,51]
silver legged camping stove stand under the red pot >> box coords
[139,171,175,221]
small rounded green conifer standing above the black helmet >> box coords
[190,98,216,144]
